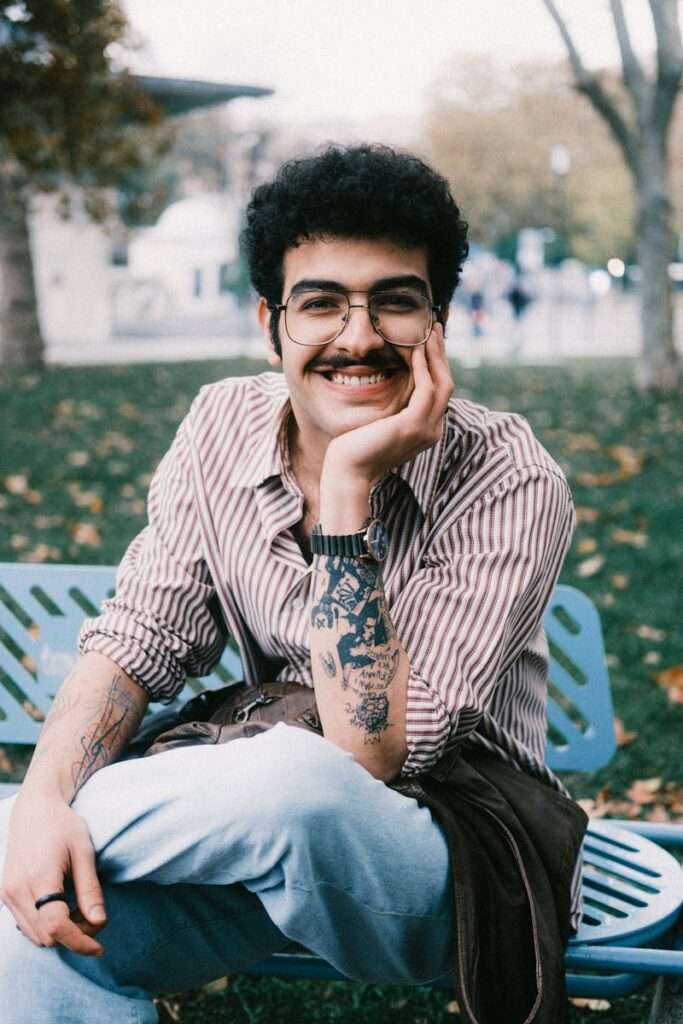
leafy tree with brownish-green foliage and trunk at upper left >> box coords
[0,0,161,367]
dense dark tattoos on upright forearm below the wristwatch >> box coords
[310,556,400,743]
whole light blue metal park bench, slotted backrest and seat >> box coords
[0,563,683,1020]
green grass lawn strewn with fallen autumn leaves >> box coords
[0,360,683,1024]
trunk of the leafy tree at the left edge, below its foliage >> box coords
[0,178,44,368]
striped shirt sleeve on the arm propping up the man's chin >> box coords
[391,466,573,775]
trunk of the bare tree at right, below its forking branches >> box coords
[636,139,681,392]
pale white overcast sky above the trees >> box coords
[124,0,663,128]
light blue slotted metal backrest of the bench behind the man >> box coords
[0,562,615,771]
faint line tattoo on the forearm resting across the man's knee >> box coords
[72,675,138,796]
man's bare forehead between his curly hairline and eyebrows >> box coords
[283,238,429,296]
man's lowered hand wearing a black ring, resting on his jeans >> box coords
[0,792,106,956]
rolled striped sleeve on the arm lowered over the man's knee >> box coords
[79,418,226,701]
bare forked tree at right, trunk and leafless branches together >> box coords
[543,0,683,391]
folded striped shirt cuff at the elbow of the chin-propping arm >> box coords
[400,669,455,775]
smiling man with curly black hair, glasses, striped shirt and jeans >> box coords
[0,146,572,1024]
